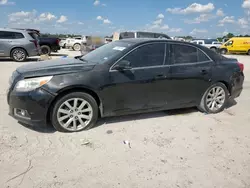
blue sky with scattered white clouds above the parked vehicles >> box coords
[0,0,250,37]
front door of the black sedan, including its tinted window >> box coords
[100,42,169,116]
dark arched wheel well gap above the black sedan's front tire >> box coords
[46,88,101,122]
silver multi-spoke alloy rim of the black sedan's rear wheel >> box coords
[206,86,226,112]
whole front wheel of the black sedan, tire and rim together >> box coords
[51,92,99,132]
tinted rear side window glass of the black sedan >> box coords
[172,44,210,64]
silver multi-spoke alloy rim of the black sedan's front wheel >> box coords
[57,98,93,131]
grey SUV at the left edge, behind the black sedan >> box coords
[0,28,40,62]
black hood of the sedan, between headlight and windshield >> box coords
[17,58,95,77]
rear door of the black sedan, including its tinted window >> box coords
[170,43,213,107]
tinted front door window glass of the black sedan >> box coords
[123,43,165,67]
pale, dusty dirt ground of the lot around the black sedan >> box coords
[0,50,250,188]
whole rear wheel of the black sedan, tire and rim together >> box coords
[198,82,229,114]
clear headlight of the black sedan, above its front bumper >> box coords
[15,76,53,91]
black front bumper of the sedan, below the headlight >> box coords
[8,88,55,126]
